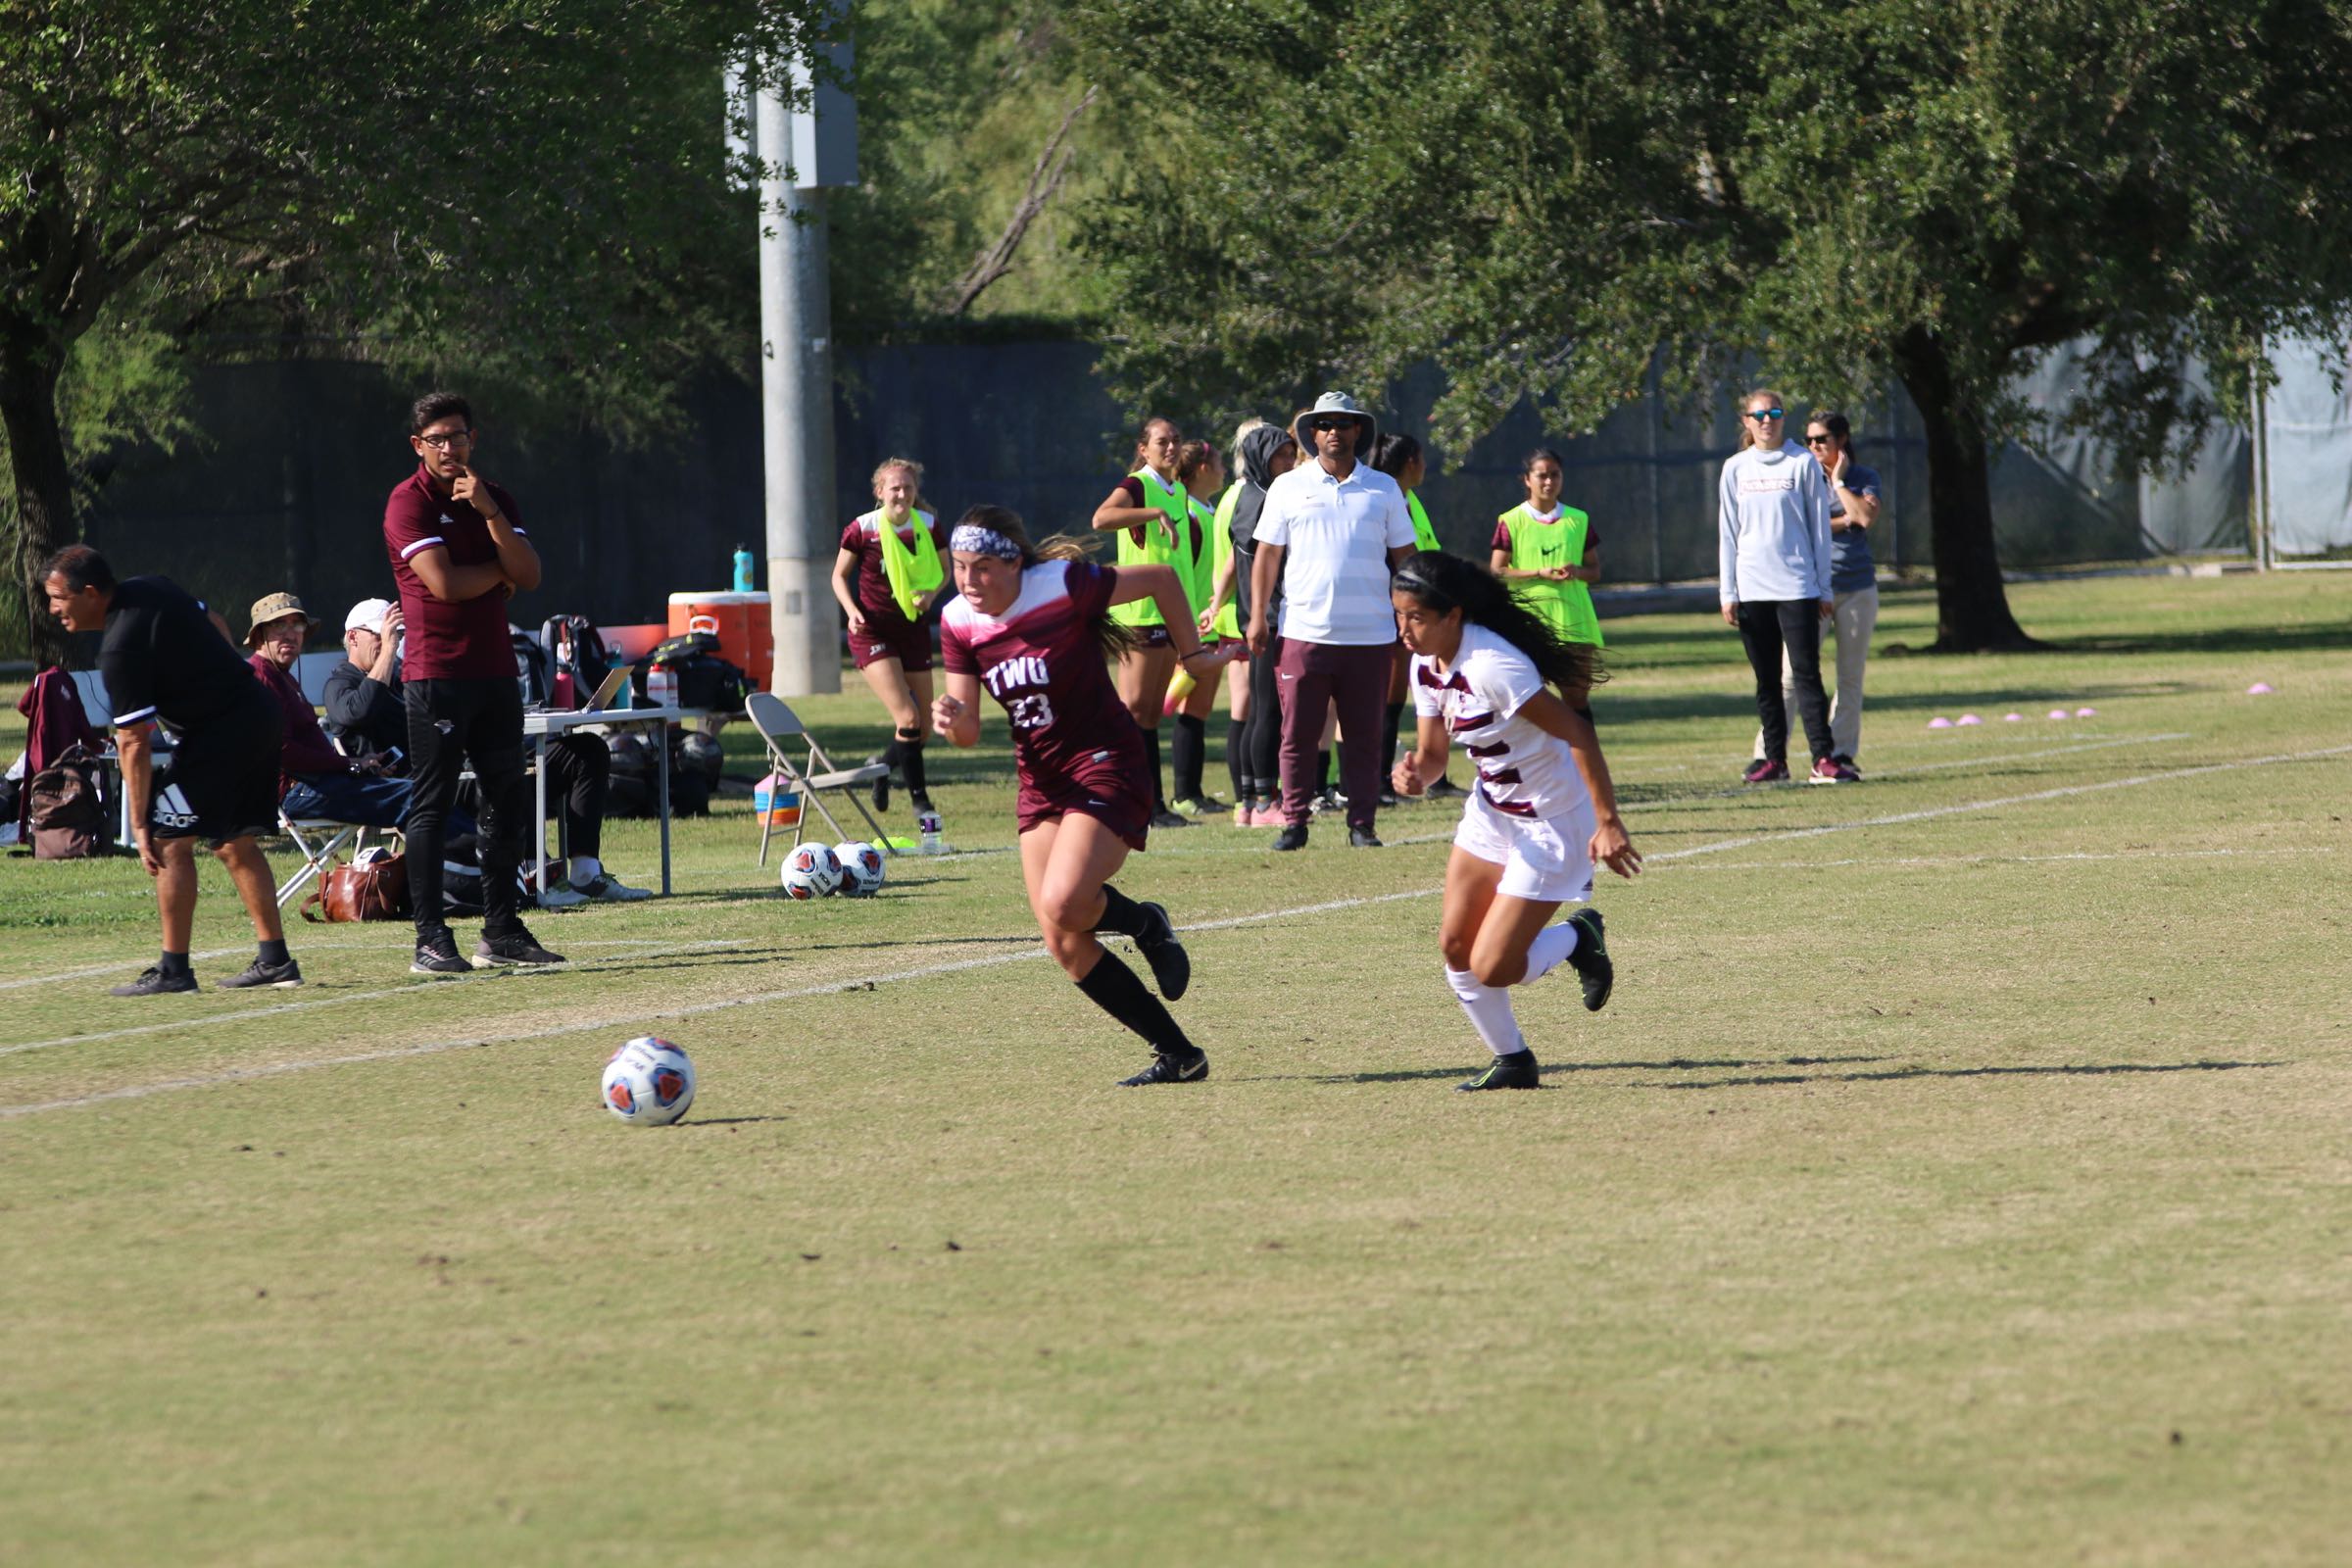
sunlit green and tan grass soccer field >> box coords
[0,573,2352,1568]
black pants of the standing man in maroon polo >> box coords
[400,674,529,941]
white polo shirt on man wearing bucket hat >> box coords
[1256,459,1413,647]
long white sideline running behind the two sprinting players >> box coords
[0,745,2352,1119]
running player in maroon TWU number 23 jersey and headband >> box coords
[931,506,1230,1086]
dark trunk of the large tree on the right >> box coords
[1895,326,2041,654]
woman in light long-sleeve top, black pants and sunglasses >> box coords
[1717,390,1848,783]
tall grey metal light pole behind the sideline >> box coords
[753,25,857,696]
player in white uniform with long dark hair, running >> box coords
[1390,550,1642,1089]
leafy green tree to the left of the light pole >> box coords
[0,0,830,647]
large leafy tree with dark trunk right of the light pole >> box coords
[1070,0,2352,649]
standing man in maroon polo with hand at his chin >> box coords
[383,393,563,976]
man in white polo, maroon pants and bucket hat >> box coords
[1249,393,1413,849]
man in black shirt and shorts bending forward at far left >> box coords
[40,546,301,997]
